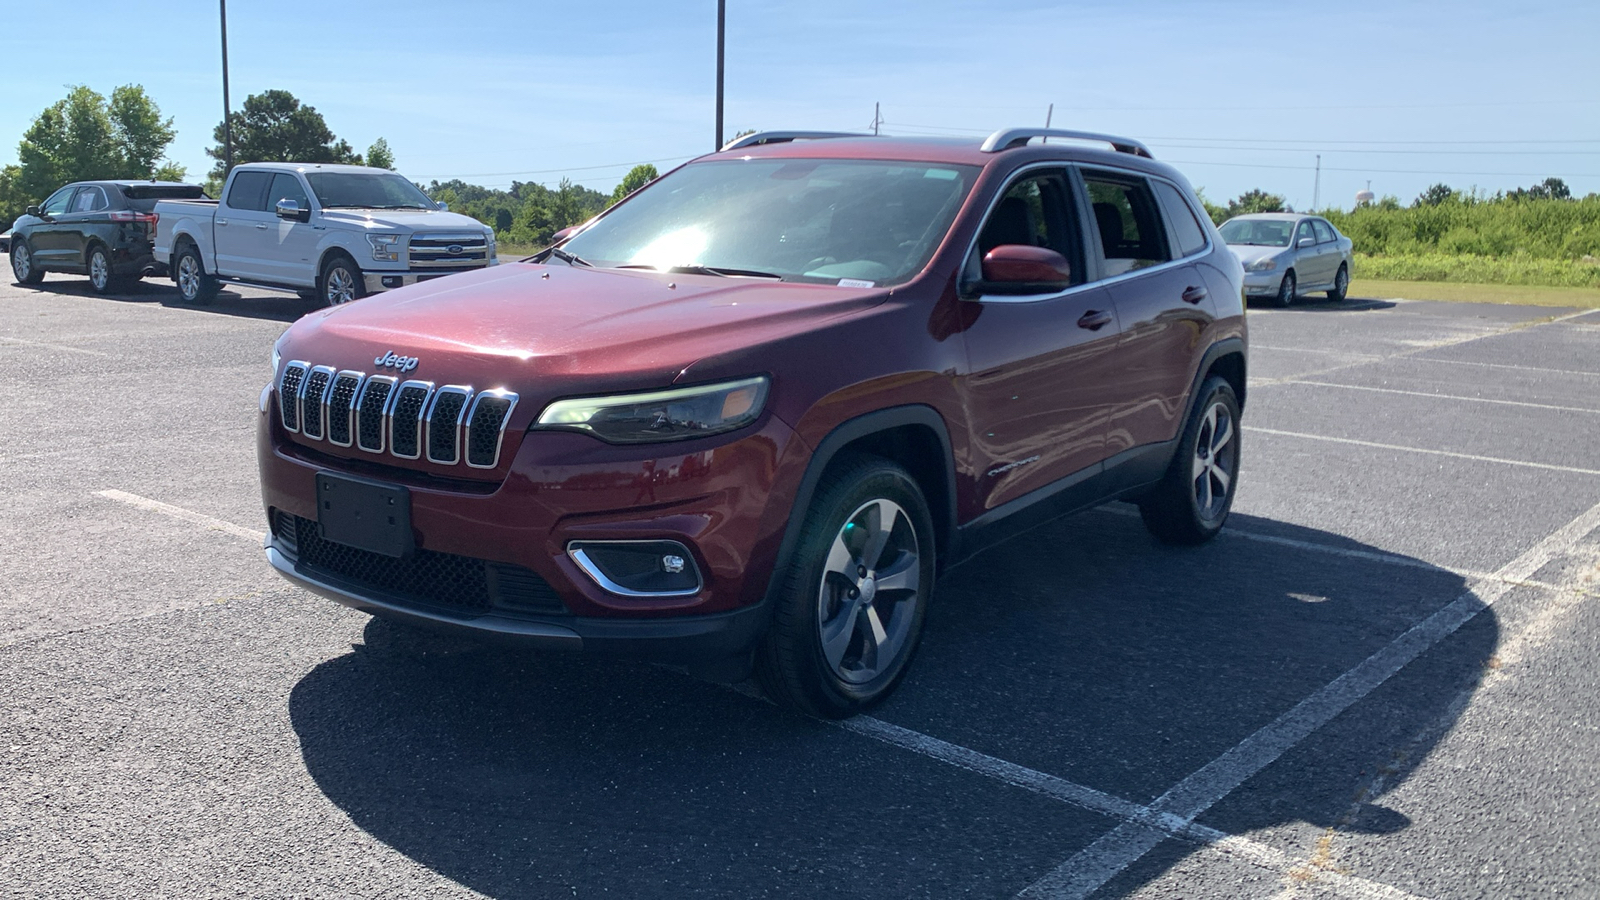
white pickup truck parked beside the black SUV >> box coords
[154,162,496,306]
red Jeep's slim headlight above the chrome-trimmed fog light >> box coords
[533,376,766,444]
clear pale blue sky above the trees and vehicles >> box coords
[0,0,1600,208]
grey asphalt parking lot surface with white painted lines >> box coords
[0,275,1600,898]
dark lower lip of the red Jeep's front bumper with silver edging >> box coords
[266,536,766,665]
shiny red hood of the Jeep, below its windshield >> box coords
[280,263,888,399]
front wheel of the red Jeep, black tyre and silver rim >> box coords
[755,456,934,719]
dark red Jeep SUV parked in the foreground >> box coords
[258,130,1245,717]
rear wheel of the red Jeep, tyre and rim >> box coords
[1139,375,1240,544]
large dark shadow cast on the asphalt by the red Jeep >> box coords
[290,508,1499,897]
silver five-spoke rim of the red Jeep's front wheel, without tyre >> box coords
[816,498,922,684]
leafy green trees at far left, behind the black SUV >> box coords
[14,85,174,200]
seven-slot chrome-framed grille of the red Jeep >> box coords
[277,360,517,469]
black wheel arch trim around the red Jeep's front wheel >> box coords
[765,404,955,607]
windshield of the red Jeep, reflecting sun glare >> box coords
[562,159,978,287]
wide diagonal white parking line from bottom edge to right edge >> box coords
[1019,504,1600,897]
